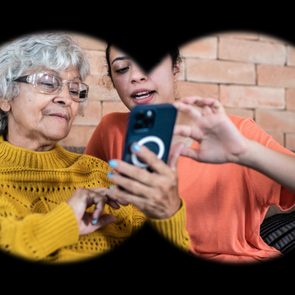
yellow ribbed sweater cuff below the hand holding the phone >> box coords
[133,200,191,251]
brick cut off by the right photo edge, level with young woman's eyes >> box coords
[257,65,295,88]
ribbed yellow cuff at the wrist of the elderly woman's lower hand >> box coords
[35,203,79,254]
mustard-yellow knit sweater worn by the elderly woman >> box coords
[0,136,189,262]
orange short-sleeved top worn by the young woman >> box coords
[86,113,295,262]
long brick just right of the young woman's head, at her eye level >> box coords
[186,59,255,84]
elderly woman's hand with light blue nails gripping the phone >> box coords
[110,145,181,219]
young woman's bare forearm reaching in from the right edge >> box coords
[235,140,295,191]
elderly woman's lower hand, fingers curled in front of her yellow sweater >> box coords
[68,188,119,235]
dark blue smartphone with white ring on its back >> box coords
[123,103,177,168]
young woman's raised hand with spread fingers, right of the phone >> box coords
[174,96,247,163]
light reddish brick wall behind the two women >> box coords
[62,32,295,150]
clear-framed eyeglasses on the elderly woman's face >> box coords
[13,72,89,102]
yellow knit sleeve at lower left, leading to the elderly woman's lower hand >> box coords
[0,198,79,260]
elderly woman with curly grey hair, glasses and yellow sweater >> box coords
[0,33,189,262]
